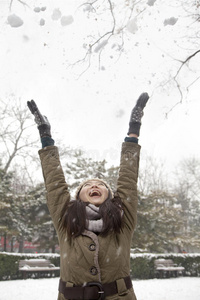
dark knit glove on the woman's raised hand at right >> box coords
[128,93,149,136]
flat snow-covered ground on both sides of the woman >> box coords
[0,277,200,300]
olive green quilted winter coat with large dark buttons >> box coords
[39,142,140,300]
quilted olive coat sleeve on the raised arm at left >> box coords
[39,146,70,230]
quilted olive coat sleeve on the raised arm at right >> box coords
[117,142,140,231]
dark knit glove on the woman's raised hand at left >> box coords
[27,100,51,138]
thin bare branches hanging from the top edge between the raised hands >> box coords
[72,0,145,76]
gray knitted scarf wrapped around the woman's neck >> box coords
[86,204,103,232]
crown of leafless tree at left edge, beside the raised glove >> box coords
[0,97,36,174]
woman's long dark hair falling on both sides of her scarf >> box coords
[60,193,123,238]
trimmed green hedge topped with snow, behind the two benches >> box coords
[0,252,200,280]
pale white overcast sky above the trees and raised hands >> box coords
[0,0,200,175]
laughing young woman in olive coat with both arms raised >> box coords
[27,93,149,300]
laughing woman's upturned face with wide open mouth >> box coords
[79,180,108,206]
